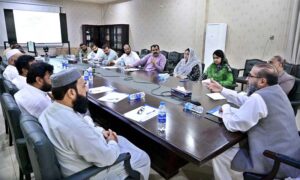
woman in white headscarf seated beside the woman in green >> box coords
[173,48,202,81]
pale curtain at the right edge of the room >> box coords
[286,0,300,64]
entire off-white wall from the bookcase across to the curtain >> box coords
[102,0,291,68]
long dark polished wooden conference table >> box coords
[50,60,246,179]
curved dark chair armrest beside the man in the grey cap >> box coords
[65,153,131,180]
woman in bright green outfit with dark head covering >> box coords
[204,50,233,87]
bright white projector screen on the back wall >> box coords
[13,10,62,43]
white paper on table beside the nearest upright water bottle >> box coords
[124,105,158,122]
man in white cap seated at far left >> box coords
[3,49,22,81]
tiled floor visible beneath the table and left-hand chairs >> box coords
[0,106,213,180]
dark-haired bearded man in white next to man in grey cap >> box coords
[14,62,53,118]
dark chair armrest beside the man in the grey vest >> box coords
[264,150,300,169]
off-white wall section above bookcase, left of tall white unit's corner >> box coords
[102,0,205,57]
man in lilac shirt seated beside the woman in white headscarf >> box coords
[126,44,167,72]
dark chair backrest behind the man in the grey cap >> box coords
[21,114,62,180]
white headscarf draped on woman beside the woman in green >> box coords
[174,48,202,76]
